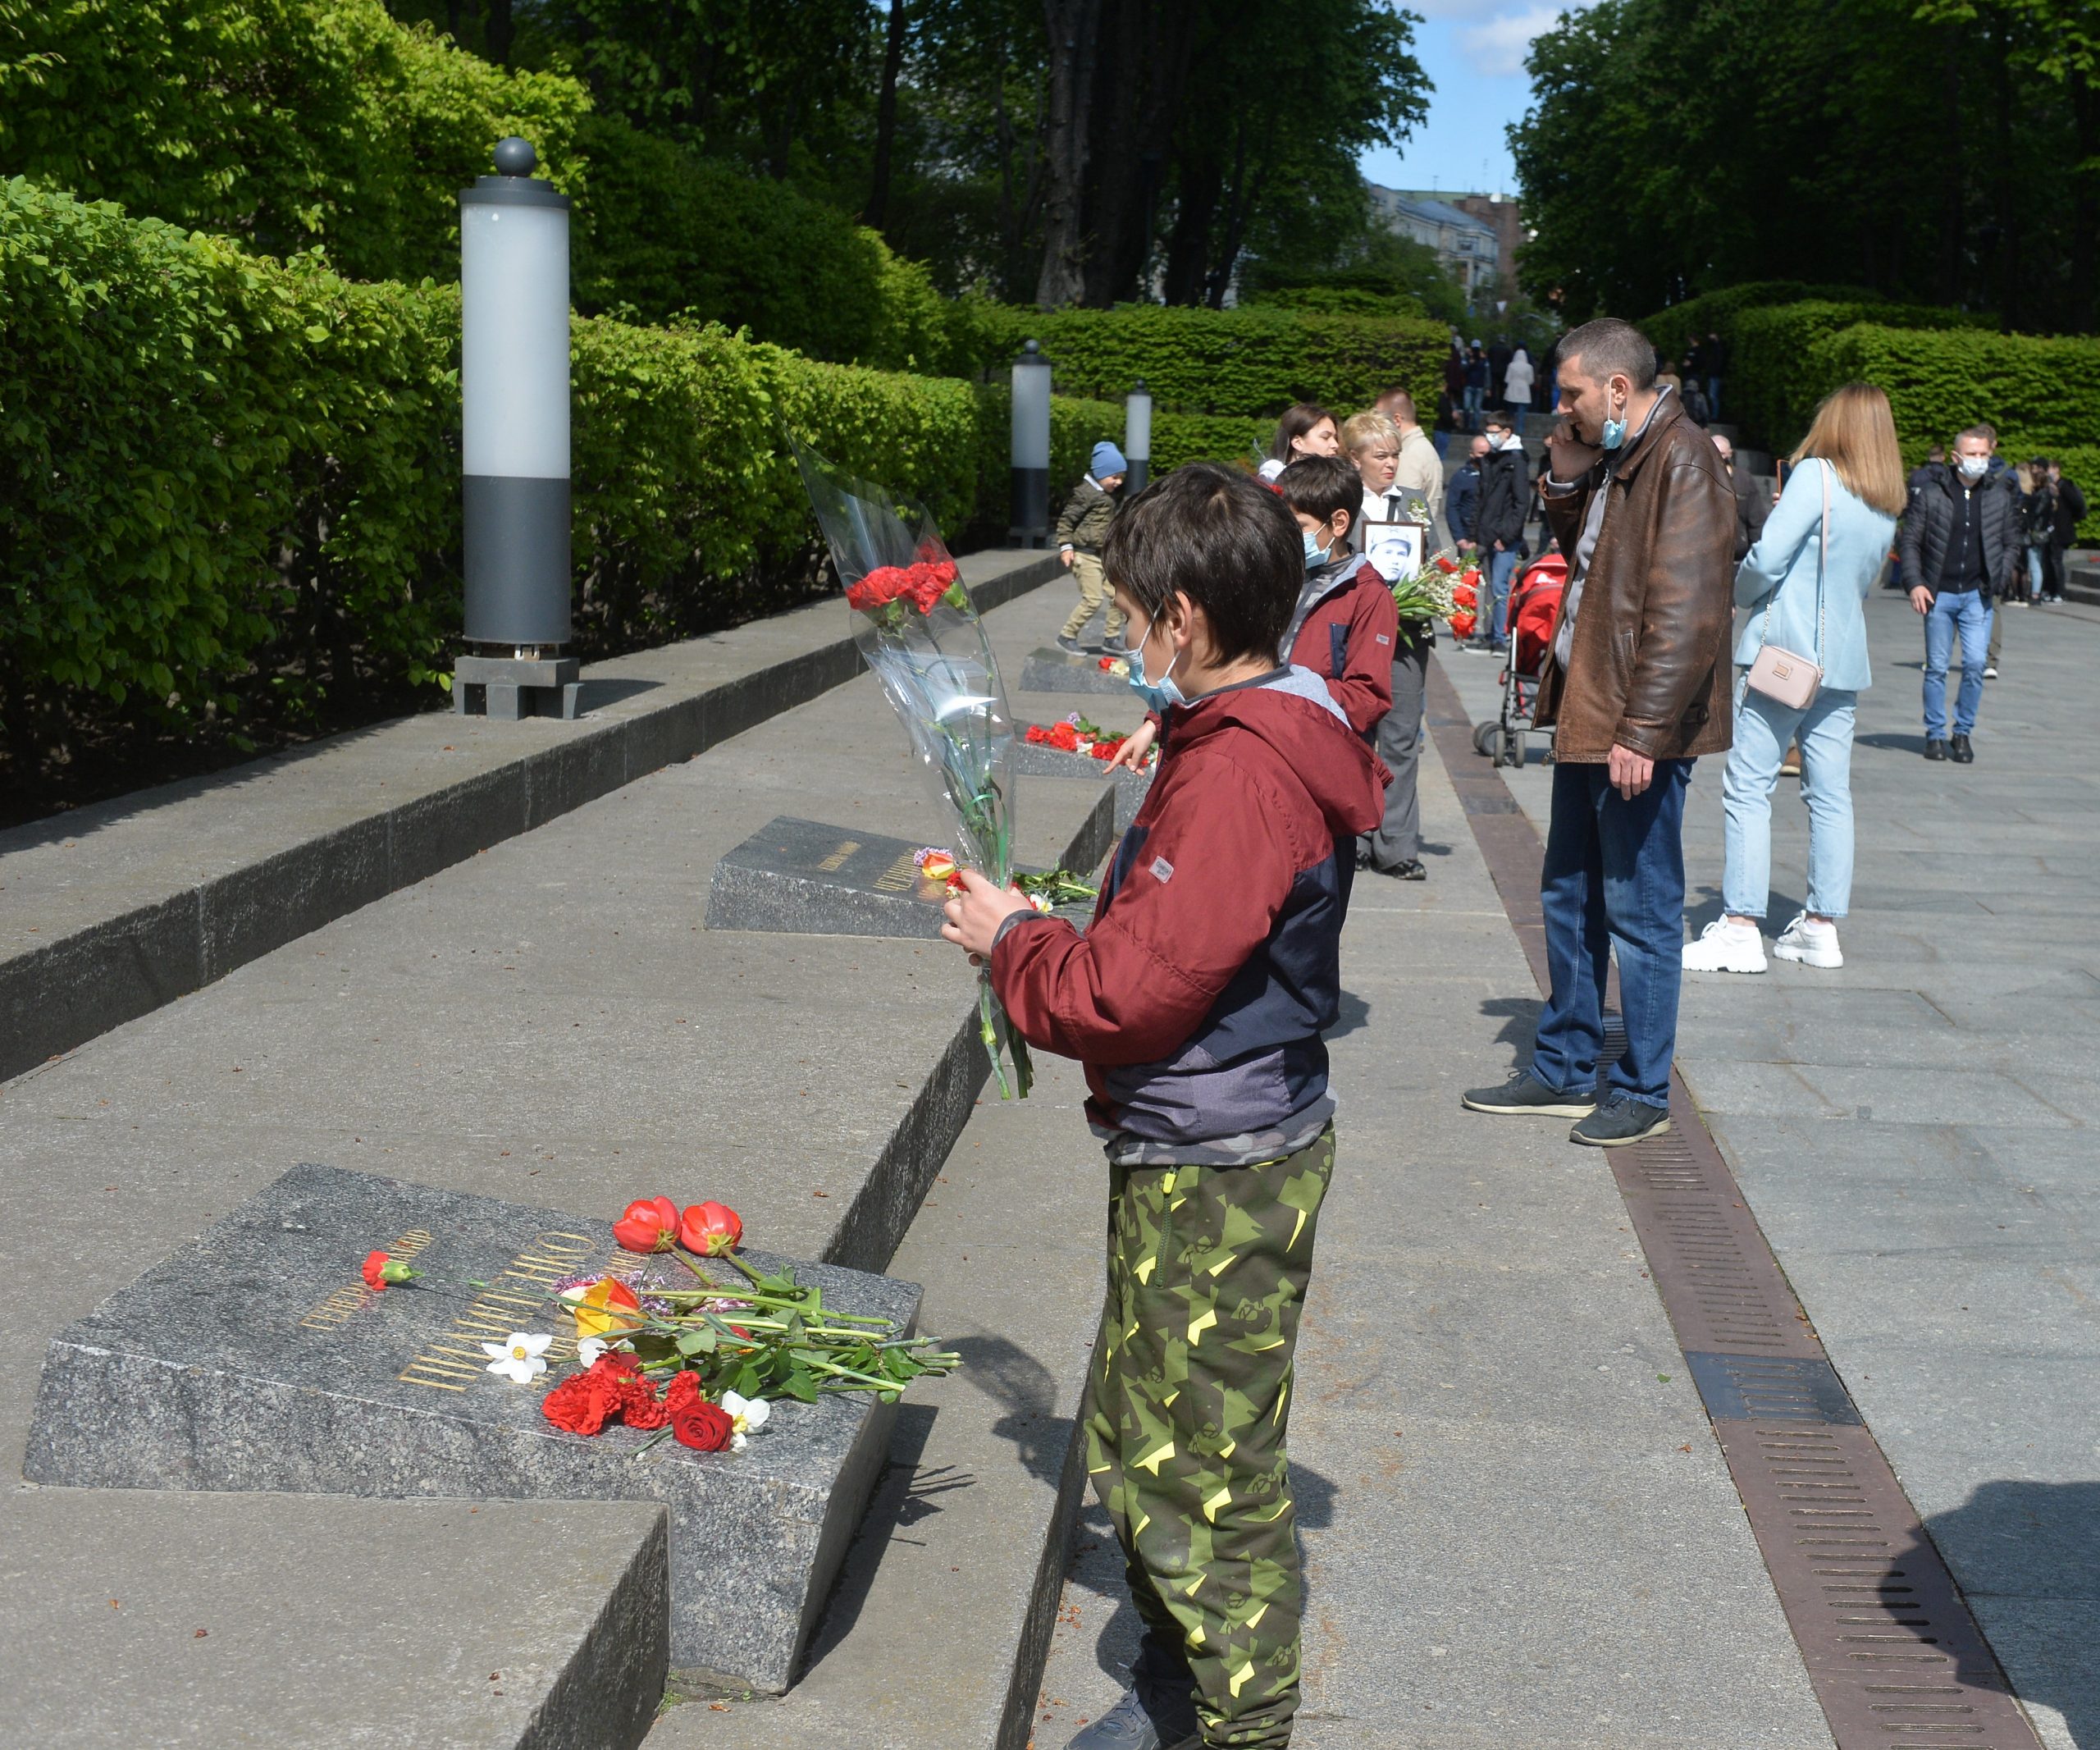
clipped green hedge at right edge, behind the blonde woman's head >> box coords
[1800,323,2100,540]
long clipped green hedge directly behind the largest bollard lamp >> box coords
[0,179,981,724]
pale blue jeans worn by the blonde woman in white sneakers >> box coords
[1720,681,1859,918]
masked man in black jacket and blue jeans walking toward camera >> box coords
[1901,427,2020,765]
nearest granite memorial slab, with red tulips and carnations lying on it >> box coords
[23,1164,920,1691]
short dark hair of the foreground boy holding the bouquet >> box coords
[1100,456,1293,662]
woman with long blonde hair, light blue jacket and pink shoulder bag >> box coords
[1684,382,1905,973]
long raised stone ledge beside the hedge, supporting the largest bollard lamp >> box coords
[0,552,1058,1078]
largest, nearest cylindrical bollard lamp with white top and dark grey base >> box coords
[454,136,575,716]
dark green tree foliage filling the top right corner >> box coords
[1510,0,2100,330]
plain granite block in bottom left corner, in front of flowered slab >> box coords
[0,1487,668,1750]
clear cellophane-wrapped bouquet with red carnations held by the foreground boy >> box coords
[796,445,1034,1099]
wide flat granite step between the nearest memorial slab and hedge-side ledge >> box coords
[0,592,1134,1743]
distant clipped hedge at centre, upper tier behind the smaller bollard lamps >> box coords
[947,300,1451,422]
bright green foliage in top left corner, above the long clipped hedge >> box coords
[0,0,590,280]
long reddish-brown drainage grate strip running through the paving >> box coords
[1428,660,2041,1750]
